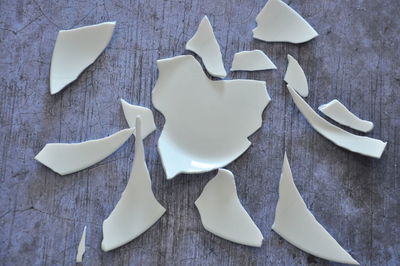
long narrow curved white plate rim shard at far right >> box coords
[287,85,386,159]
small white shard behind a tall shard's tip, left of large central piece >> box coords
[121,99,156,139]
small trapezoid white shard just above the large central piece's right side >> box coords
[231,50,276,71]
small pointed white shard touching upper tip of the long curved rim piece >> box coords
[283,54,308,97]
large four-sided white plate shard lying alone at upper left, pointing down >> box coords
[50,21,115,94]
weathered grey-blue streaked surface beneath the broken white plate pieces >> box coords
[0,0,400,265]
